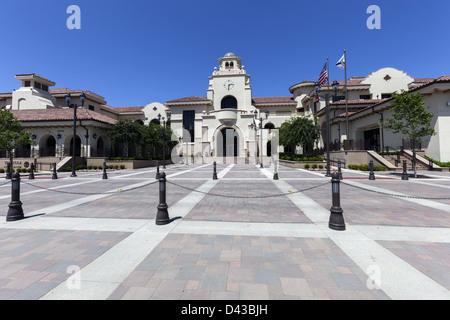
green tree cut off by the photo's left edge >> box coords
[0,109,34,168]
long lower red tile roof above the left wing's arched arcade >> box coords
[11,108,117,124]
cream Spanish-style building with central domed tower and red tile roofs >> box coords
[0,53,450,170]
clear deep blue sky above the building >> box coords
[0,0,450,107]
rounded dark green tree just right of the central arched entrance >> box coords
[279,117,320,155]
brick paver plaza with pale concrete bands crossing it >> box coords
[0,164,450,300]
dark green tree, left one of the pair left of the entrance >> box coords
[110,119,142,157]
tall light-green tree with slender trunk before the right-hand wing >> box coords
[381,90,436,176]
